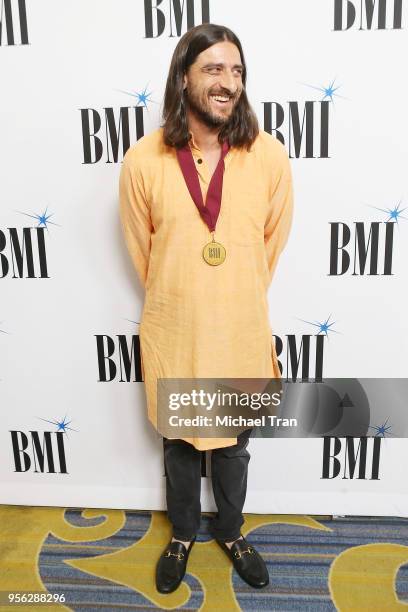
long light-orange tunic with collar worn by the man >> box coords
[119,128,293,450]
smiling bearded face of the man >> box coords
[184,41,243,128]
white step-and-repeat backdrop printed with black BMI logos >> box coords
[0,0,408,516]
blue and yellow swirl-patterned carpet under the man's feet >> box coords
[0,506,408,612]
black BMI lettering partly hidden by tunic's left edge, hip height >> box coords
[95,335,143,382]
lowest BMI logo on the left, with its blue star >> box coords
[10,416,76,474]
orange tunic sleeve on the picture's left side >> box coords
[119,152,153,287]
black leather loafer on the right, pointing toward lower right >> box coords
[217,537,269,589]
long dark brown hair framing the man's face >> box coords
[162,23,259,150]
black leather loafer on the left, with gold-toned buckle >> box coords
[156,538,195,593]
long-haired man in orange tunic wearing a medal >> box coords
[120,24,292,593]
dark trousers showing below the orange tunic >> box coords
[163,429,252,542]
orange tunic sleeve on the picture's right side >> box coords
[264,143,293,282]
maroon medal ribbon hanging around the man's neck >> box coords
[176,141,229,232]
